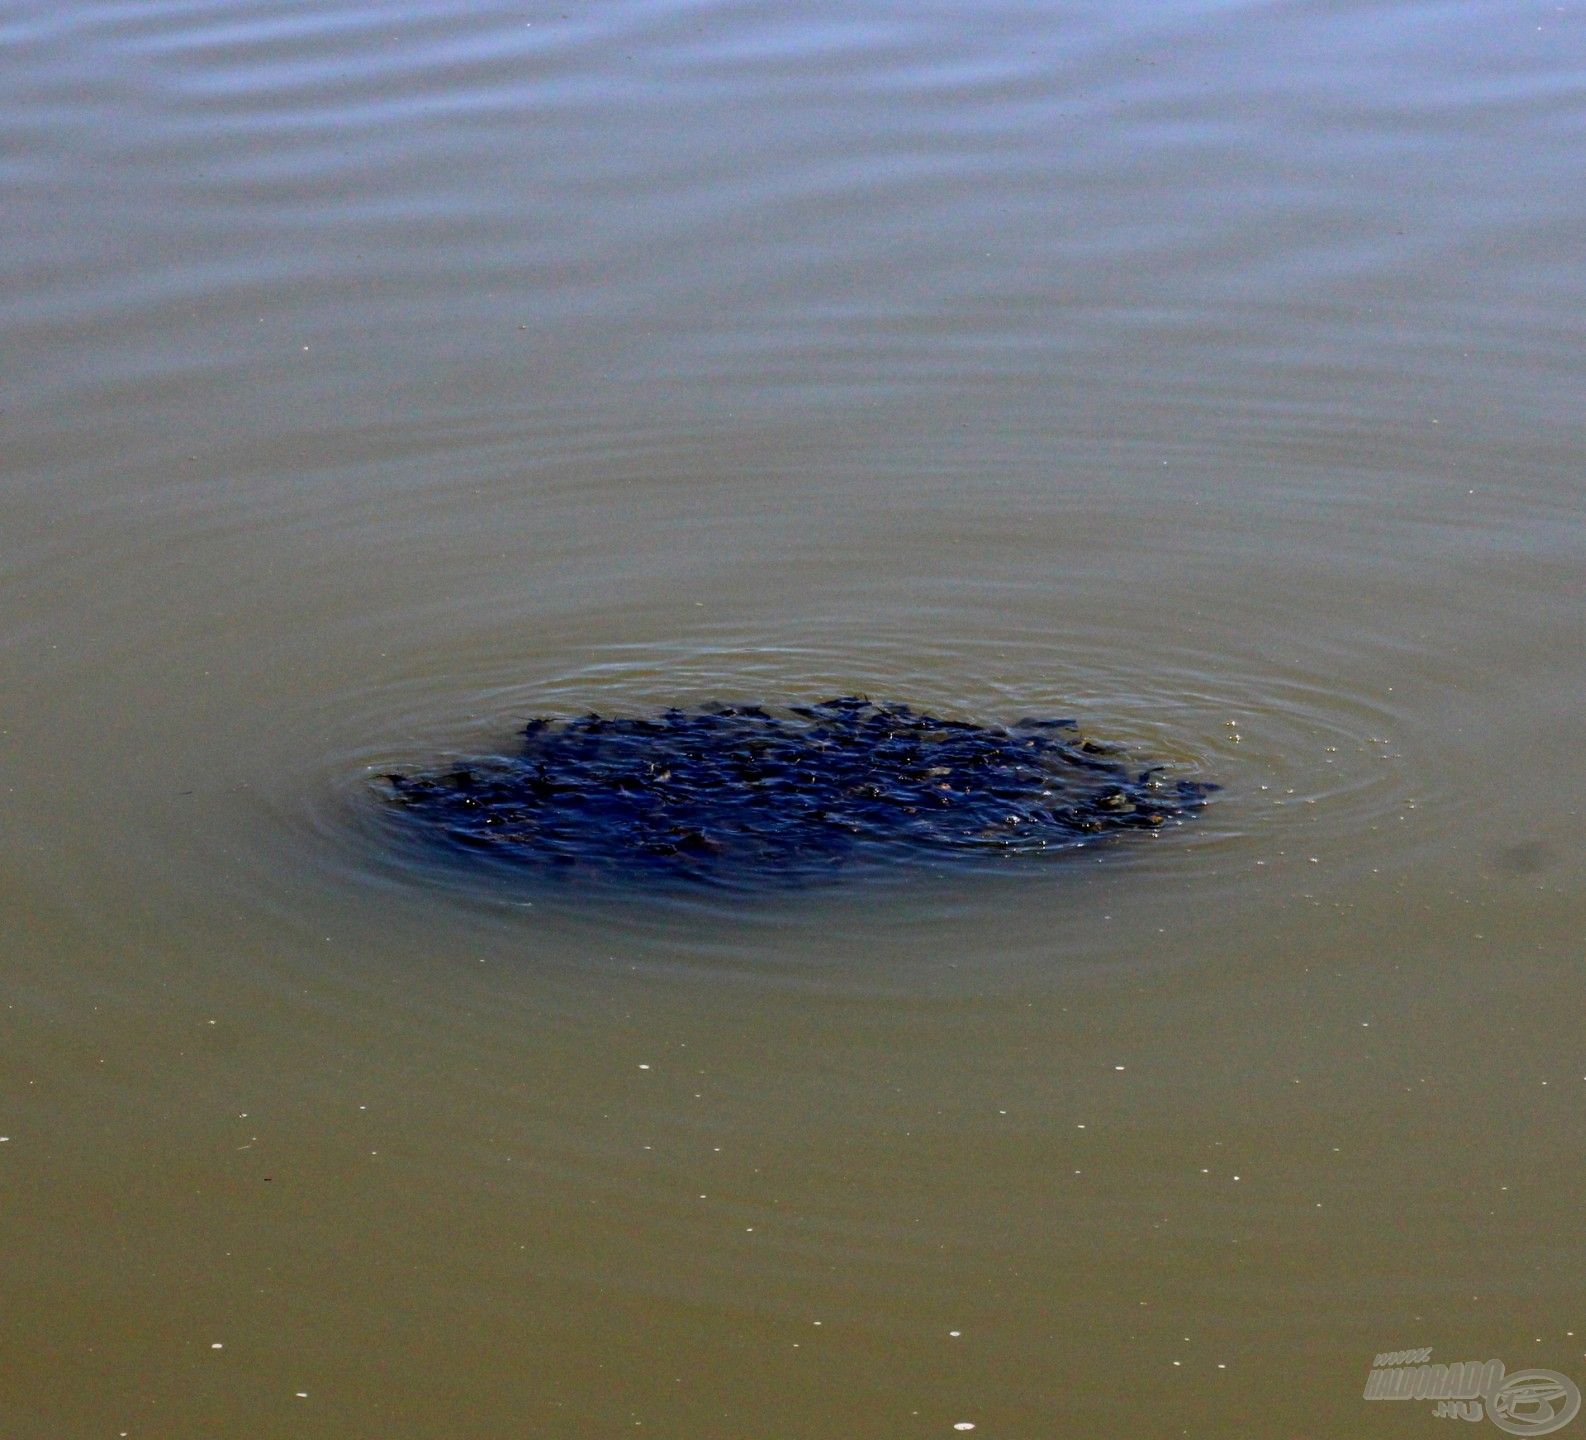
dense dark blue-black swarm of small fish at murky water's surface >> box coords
[382,696,1215,887]
